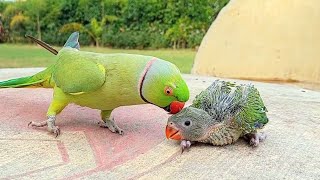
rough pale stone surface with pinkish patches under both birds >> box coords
[0,69,320,179]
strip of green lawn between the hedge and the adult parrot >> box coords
[0,44,196,73]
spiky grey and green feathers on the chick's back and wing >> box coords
[192,81,268,133]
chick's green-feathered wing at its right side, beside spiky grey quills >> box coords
[233,85,269,133]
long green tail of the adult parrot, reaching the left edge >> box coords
[0,66,55,88]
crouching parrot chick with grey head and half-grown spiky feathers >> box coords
[166,80,268,152]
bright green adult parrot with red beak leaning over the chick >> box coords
[0,32,189,136]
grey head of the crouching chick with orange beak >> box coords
[166,107,211,141]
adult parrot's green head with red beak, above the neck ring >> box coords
[140,59,189,114]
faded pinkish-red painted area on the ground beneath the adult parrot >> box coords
[0,88,168,177]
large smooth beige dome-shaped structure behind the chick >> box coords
[192,0,320,83]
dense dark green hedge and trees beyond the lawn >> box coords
[0,0,229,49]
